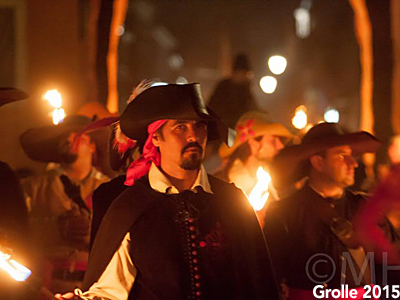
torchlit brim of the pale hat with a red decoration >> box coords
[218,123,293,158]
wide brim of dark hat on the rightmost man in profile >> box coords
[270,131,381,189]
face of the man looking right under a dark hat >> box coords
[320,146,358,188]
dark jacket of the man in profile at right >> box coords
[264,185,397,290]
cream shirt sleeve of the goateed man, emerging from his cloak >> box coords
[75,232,137,300]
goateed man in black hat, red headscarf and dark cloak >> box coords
[56,84,278,300]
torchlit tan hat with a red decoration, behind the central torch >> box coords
[219,111,293,158]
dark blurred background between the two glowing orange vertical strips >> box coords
[120,0,360,127]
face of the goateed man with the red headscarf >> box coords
[153,120,207,170]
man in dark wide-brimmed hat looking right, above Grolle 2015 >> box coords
[264,123,396,299]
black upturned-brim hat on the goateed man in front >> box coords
[120,83,233,145]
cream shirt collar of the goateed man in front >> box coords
[149,163,213,194]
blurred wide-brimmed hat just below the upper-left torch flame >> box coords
[20,115,100,162]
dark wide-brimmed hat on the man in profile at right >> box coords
[270,123,381,189]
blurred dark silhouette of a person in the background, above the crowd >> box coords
[209,53,257,128]
